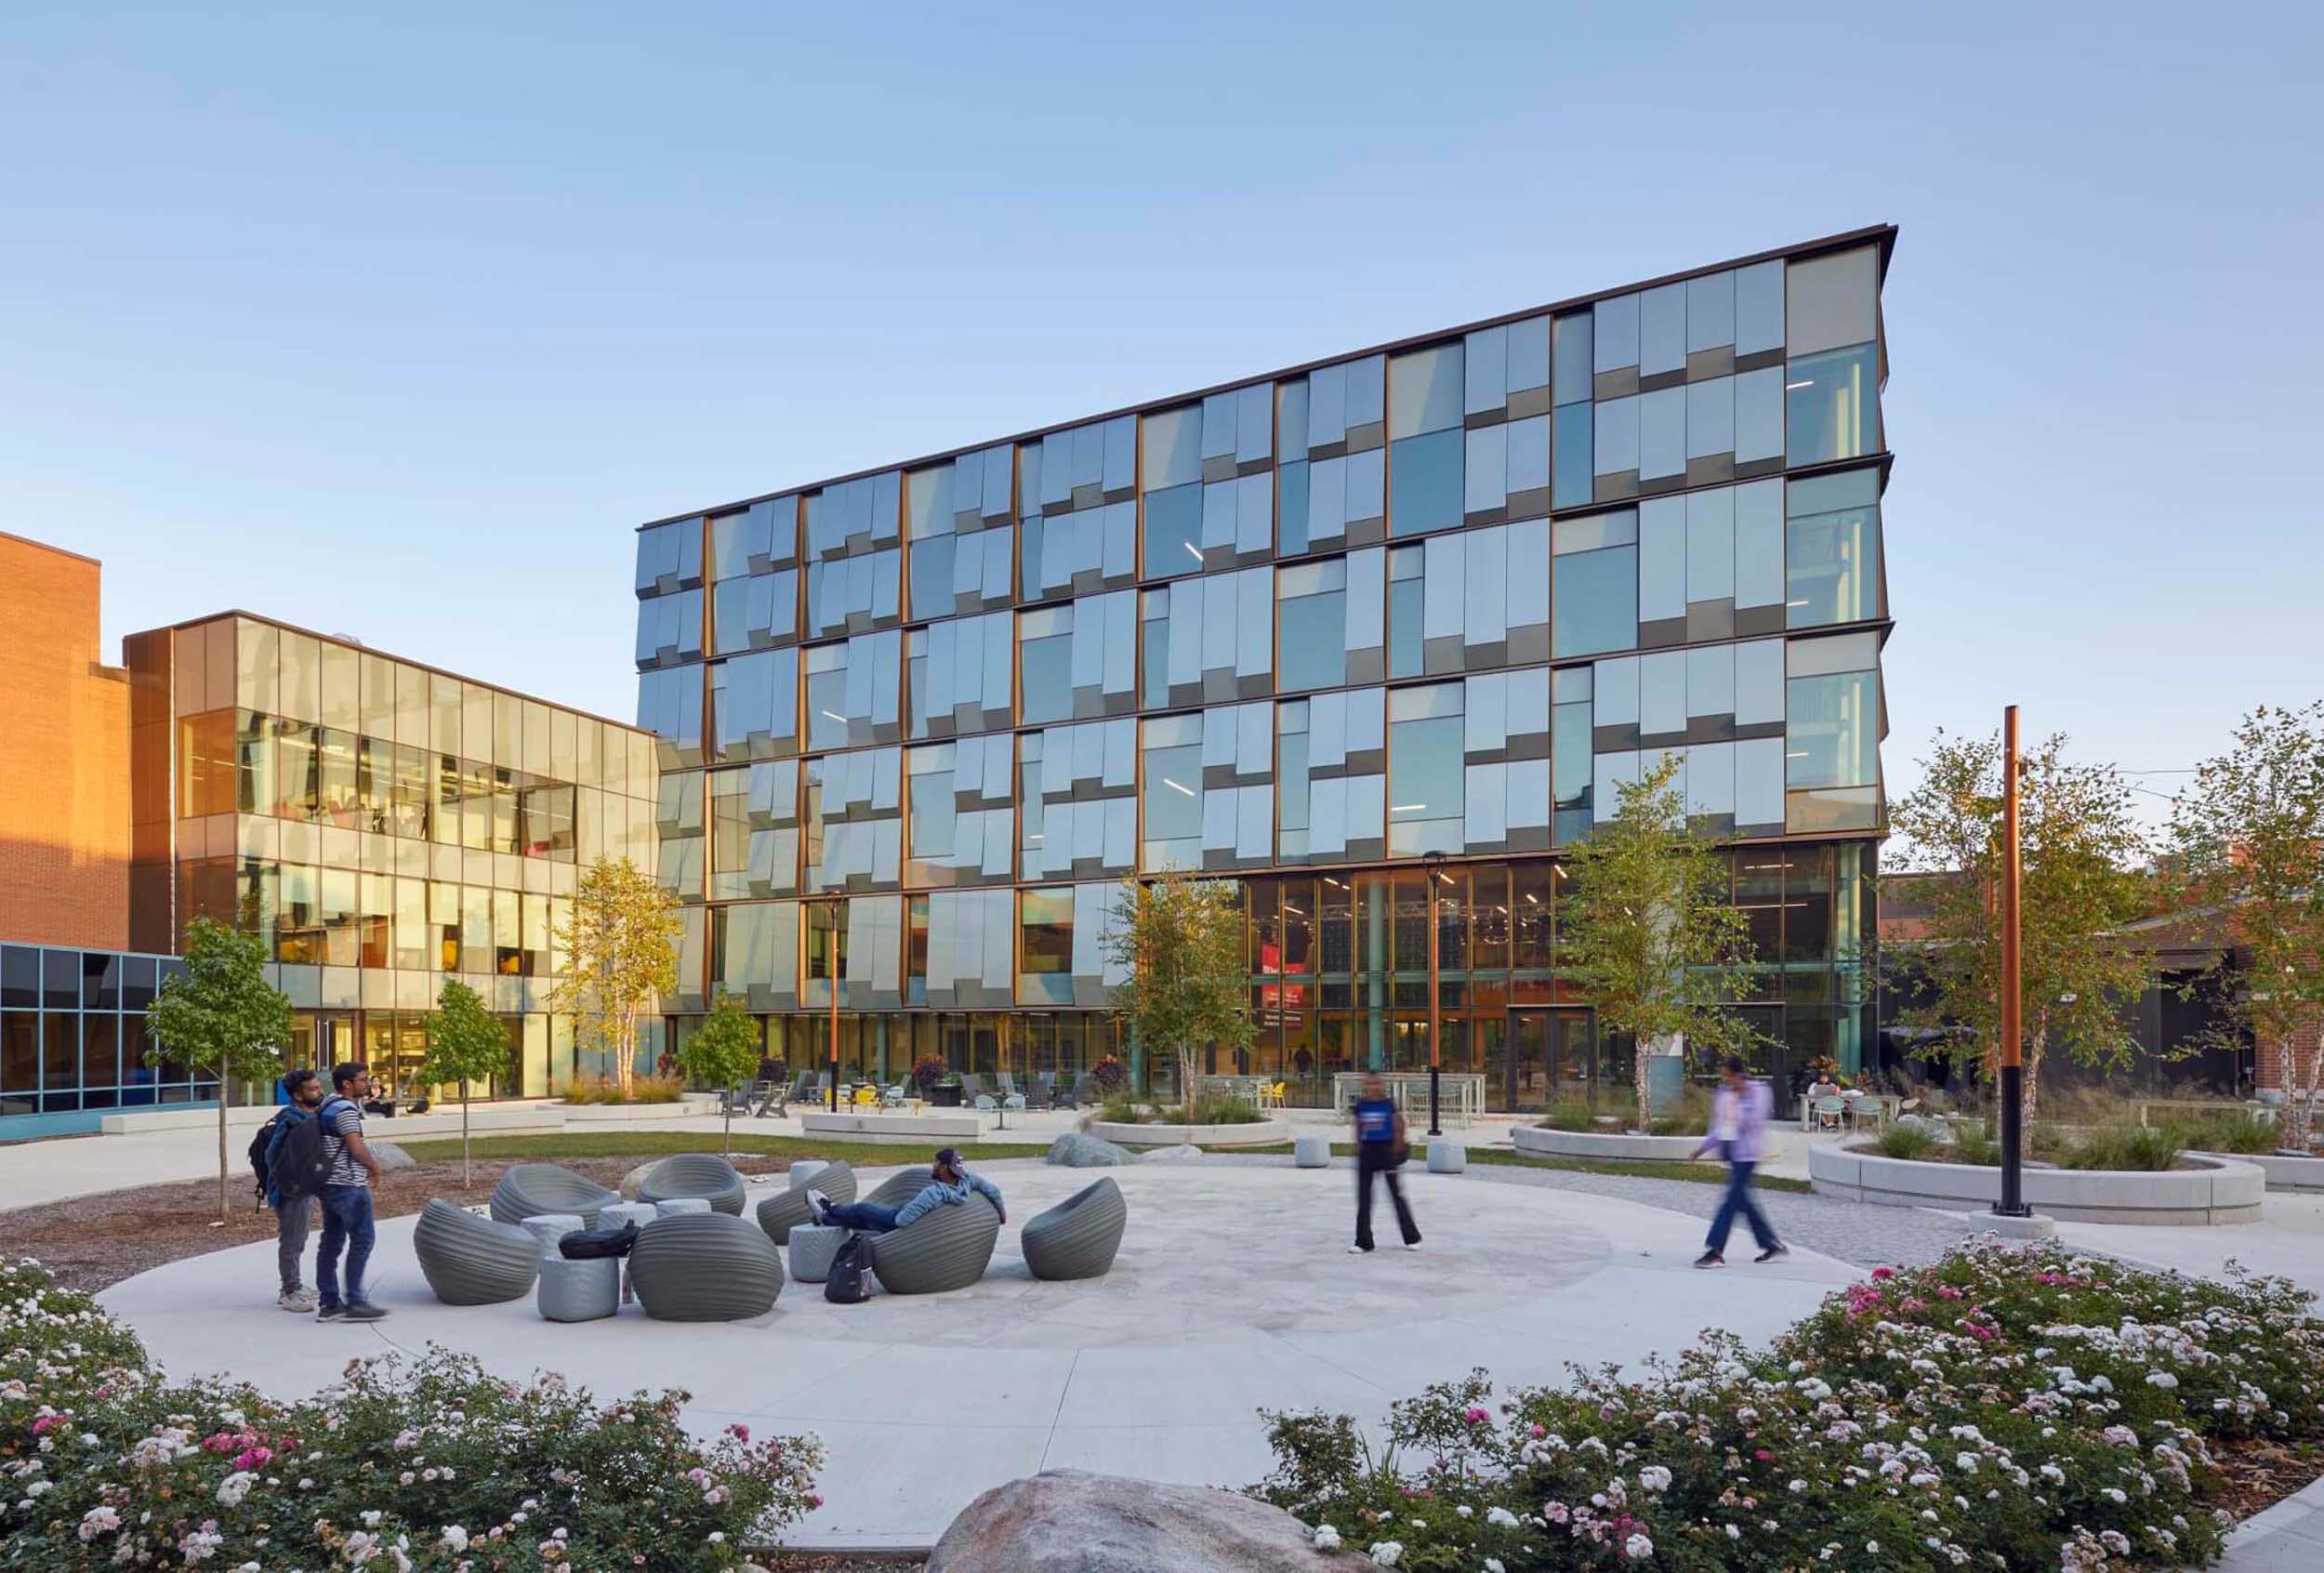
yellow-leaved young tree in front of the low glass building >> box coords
[548,857,683,1099]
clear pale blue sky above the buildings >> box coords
[0,0,2324,806]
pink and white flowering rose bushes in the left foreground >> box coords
[0,1262,823,1573]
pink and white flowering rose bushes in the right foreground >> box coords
[1253,1241,2324,1573]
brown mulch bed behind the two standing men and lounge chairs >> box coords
[0,1153,790,1294]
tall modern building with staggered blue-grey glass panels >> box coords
[637,228,1895,1108]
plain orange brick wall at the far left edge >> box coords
[0,535,130,950]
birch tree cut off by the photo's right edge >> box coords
[2171,704,2324,1153]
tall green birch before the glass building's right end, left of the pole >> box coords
[1557,758,1757,1130]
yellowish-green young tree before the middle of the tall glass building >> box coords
[1104,874,1253,1117]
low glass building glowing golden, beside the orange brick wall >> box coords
[125,611,655,1097]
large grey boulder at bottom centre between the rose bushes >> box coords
[928,1469,1332,1573]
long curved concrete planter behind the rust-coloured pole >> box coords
[1808,1145,2266,1224]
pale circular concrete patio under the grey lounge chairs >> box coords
[102,1159,1855,1548]
